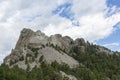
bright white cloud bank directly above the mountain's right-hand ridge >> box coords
[44,13,120,42]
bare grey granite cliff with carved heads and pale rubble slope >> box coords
[4,28,113,69]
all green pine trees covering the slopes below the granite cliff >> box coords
[0,44,120,80]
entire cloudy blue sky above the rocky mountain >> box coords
[0,0,120,62]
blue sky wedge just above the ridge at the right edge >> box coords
[97,25,120,51]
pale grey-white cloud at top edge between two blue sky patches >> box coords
[72,0,106,18]
